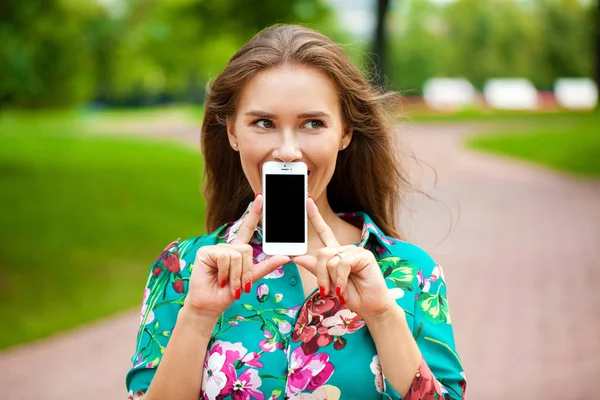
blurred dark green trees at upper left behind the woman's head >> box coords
[0,0,343,107]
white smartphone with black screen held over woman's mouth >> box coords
[262,161,308,256]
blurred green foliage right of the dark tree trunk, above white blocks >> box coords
[387,0,597,93]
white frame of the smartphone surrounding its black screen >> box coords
[262,161,308,256]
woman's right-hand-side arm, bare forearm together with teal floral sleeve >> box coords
[365,265,466,400]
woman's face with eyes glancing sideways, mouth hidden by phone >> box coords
[227,66,352,200]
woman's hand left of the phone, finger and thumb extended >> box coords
[184,194,290,318]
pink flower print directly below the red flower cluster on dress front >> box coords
[286,347,334,397]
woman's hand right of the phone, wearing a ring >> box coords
[292,198,397,319]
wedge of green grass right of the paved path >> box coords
[467,112,600,178]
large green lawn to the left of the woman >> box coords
[0,113,204,348]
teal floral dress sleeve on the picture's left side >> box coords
[126,241,190,399]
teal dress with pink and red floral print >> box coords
[126,213,466,400]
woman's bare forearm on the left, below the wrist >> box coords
[143,305,217,400]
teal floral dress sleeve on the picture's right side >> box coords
[383,265,466,400]
